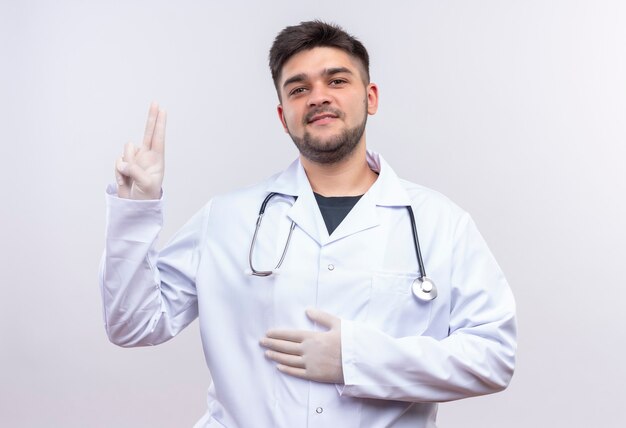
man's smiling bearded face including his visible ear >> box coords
[278,47,378,164]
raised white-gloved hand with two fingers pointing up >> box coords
[115,102,167,199]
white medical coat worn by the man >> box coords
[101,152,516,428]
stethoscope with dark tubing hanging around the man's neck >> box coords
[248,192,437,301]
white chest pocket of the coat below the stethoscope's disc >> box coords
[367,273,434,337]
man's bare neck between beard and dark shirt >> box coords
[300,141,378,196]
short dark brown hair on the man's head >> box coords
[269,20,370,92]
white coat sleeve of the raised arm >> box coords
[100,186,210,347]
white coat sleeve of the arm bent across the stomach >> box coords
[338,214,516,402]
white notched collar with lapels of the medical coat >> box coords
[267,151,410,245]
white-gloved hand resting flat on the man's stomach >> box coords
[260,309,343,384]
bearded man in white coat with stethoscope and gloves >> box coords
[101,21,516,427]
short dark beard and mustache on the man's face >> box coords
[289,99,367,164]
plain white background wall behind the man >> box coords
[0,0,626,428]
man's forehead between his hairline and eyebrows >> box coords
[280,47,362,86]
